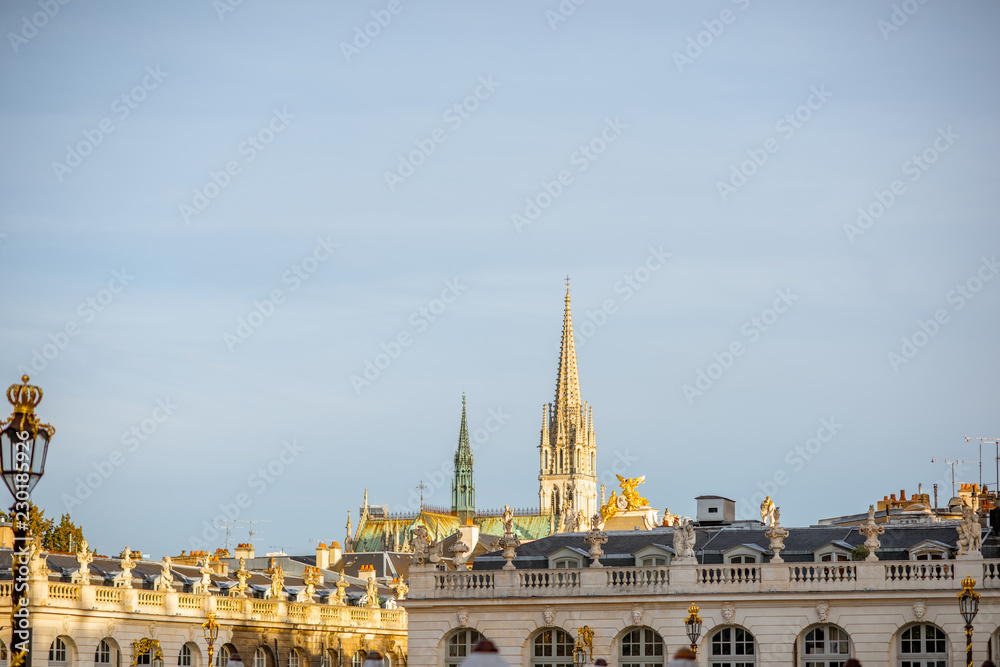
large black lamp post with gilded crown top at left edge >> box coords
[0,375,56,667]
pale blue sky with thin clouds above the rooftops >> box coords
[0,0,1000,556]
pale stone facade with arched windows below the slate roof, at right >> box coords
[404,529,1000,667]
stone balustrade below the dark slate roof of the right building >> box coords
[409,557,1000,600]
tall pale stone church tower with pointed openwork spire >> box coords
[538,282,600,519]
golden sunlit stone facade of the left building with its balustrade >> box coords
[0,552,407,667]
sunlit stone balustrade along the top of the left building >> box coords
[0,580,407,631]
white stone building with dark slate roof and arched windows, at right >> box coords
[405,496,1000,667]
